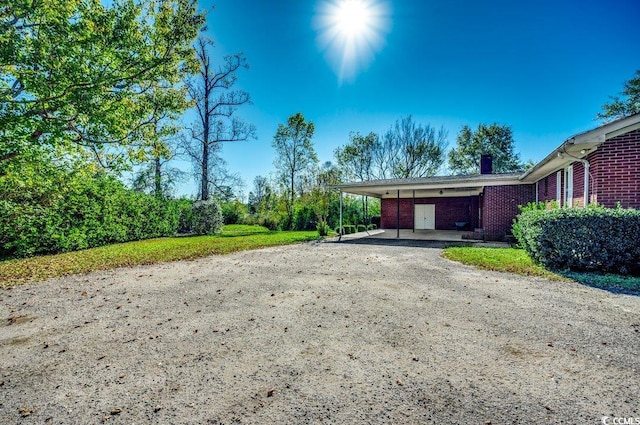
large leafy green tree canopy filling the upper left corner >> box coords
[0,0,204,167]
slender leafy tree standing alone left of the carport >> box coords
[272,112,318,225]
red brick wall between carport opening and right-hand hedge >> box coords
[482,184,536,240]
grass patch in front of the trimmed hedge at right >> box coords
[442,247,640,295]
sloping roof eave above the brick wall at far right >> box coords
[520,113,640,183]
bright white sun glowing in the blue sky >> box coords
[314,0,389,83]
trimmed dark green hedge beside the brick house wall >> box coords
[513,205,640,274]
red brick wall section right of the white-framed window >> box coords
[588,130,640,208]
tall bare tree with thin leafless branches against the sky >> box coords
[185,37,256,200]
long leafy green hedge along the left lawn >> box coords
[0,167,188,258]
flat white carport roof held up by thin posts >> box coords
[335,173,527,198]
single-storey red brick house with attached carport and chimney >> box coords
[338,114,640,240]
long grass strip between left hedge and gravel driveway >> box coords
[0,225,318,286]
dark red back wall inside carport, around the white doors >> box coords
[380,196,479,230]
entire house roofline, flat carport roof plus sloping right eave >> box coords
[335,113,640,198]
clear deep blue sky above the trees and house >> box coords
[180,0,640,198]
